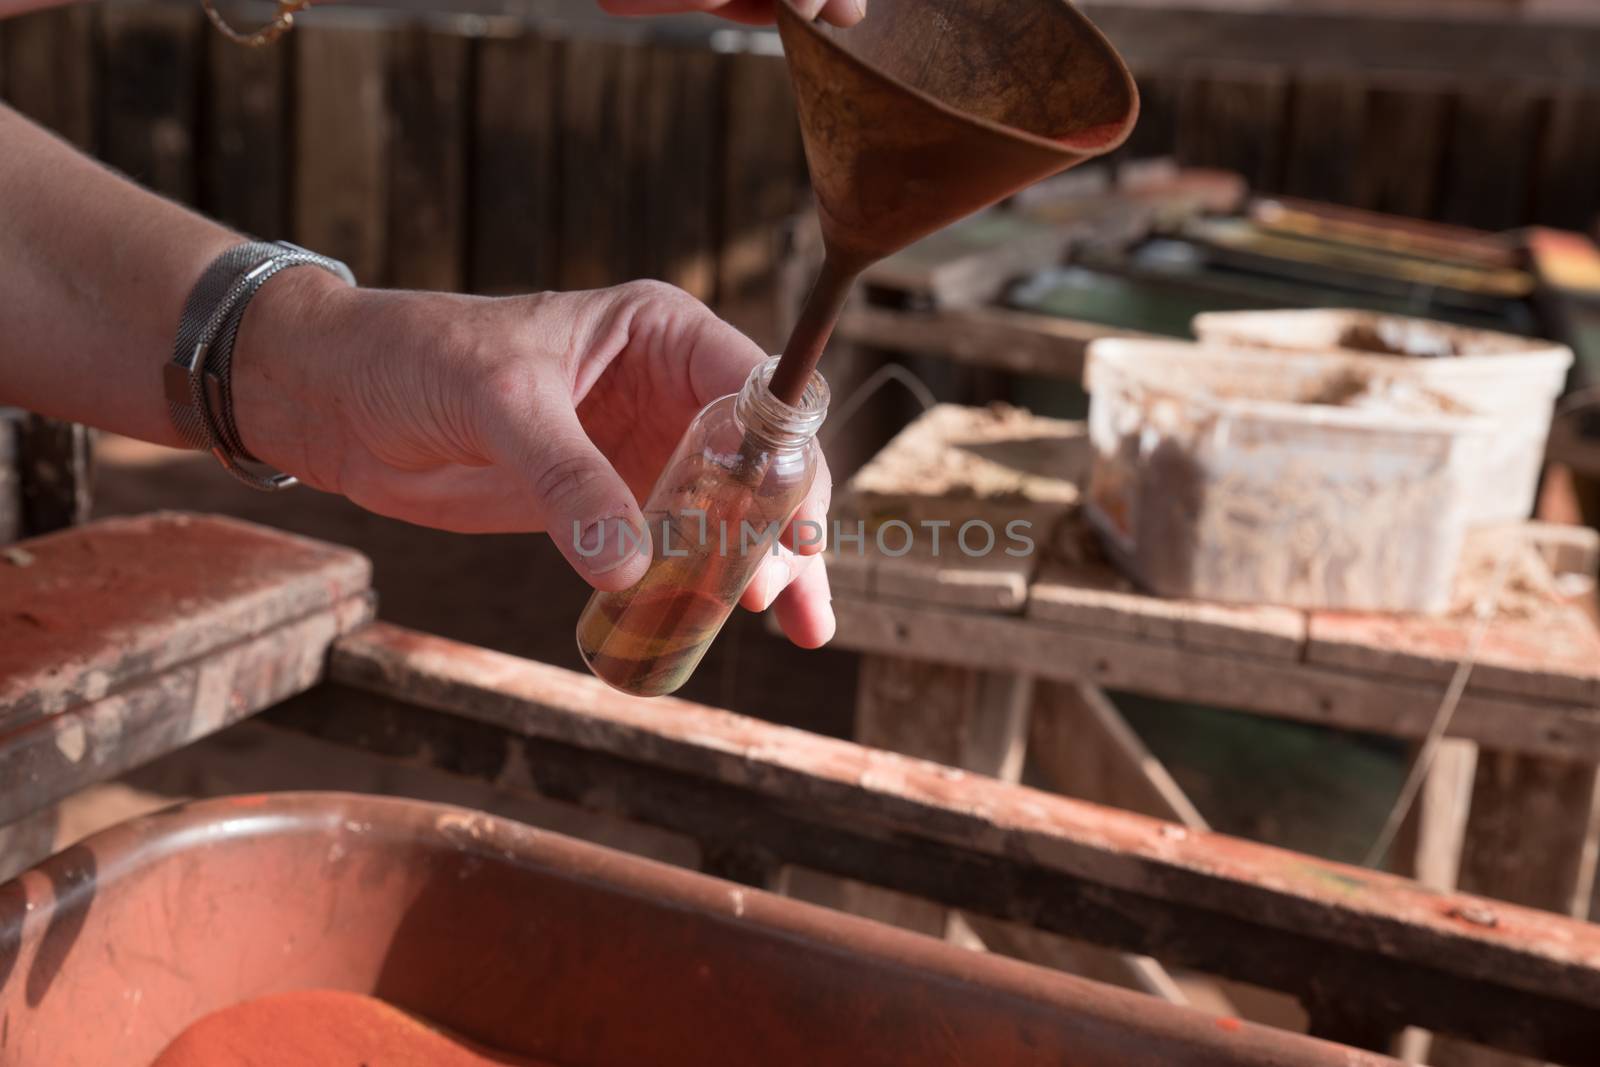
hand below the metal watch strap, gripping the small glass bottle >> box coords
[234,269,834,648]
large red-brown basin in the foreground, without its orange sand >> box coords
[0,793,1394,1067]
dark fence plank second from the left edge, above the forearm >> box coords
[101,5,205,203]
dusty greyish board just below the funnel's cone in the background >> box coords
[861,210,1074,307]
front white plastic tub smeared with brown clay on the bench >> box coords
[1085,339,1494,613]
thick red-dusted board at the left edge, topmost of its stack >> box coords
[0,514,371,726]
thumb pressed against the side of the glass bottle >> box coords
[498,391,650,590]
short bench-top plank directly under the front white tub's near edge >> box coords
[1027,560,1306,659]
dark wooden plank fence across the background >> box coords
[0,0,1600,351]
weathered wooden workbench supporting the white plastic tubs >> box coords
[829,406,1600,940]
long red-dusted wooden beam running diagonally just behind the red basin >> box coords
[302,625,1600,1062]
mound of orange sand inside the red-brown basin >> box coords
[152,990,549,1067]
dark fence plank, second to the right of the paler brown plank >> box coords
[469,27,562,294]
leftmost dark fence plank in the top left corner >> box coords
[0,5,98,152]
